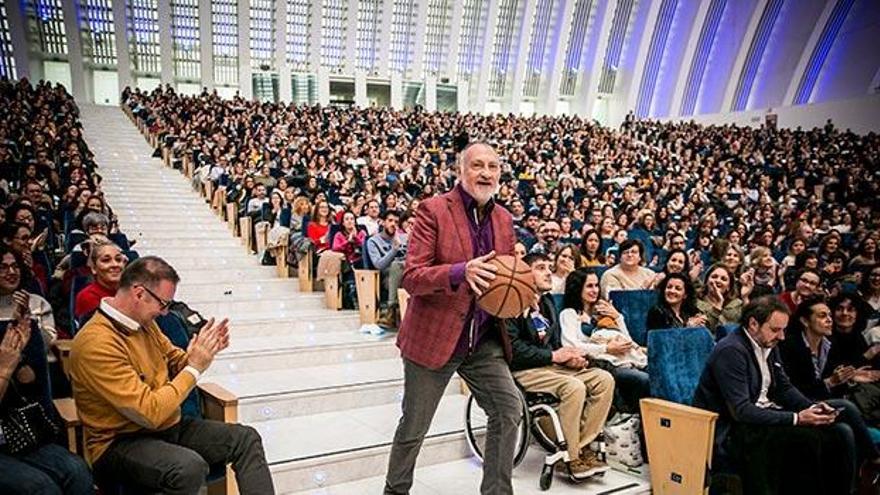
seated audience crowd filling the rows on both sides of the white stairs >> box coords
[0,73,880,493]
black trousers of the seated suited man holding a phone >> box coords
[730,399,877,495]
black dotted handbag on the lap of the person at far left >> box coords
[0,382,61,454]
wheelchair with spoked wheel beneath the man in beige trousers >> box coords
[464,383,605,490]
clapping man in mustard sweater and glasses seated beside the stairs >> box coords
[70,256,274,495]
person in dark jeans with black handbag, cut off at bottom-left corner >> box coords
[0,316,95,495]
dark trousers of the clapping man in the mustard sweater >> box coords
[93,418,275,495]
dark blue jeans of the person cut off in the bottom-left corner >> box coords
[0,444,95,495]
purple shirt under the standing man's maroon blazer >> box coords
[449,184,495,356]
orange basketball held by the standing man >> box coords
[477,255,537,318]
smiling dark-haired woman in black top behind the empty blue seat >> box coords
[645,273,706,330]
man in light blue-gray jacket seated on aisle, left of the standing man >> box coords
[366,210,407,328]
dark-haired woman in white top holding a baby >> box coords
[559,268,651,412]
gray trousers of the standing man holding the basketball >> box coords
[385,338,523,495]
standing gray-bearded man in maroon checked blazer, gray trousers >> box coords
[385,143,522,494]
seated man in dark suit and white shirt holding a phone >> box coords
[694,296,878,495]
